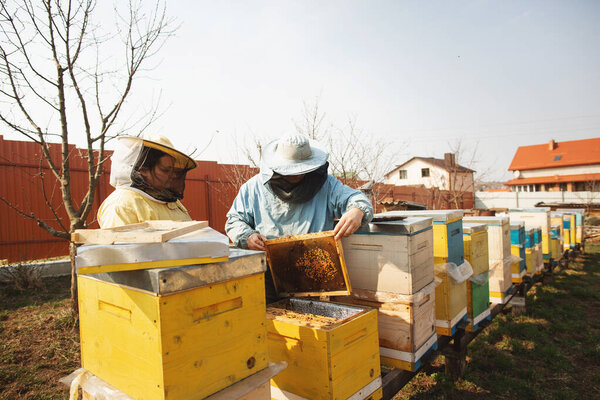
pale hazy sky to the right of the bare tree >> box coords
[4,0,600,181]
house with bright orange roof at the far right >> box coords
[505,138,600,192]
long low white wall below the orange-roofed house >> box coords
[475,192,600,209]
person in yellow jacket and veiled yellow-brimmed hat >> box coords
[98,134,198,228]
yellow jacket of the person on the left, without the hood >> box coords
[98,187,192,228]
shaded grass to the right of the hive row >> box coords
[394,243,600,400]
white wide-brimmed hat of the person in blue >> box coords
[262,135,329,175]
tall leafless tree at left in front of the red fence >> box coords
[0,0,173,310]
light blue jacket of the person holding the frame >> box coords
[225,173,373,248]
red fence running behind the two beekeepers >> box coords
[0,135,473,261]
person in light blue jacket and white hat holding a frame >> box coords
[225,135,373,250]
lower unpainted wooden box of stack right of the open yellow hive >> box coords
[336,282,437,371]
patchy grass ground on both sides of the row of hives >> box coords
[0,244,600,400]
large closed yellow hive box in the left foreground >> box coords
[77,250,268,399]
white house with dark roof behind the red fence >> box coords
[385,153,475,192]
